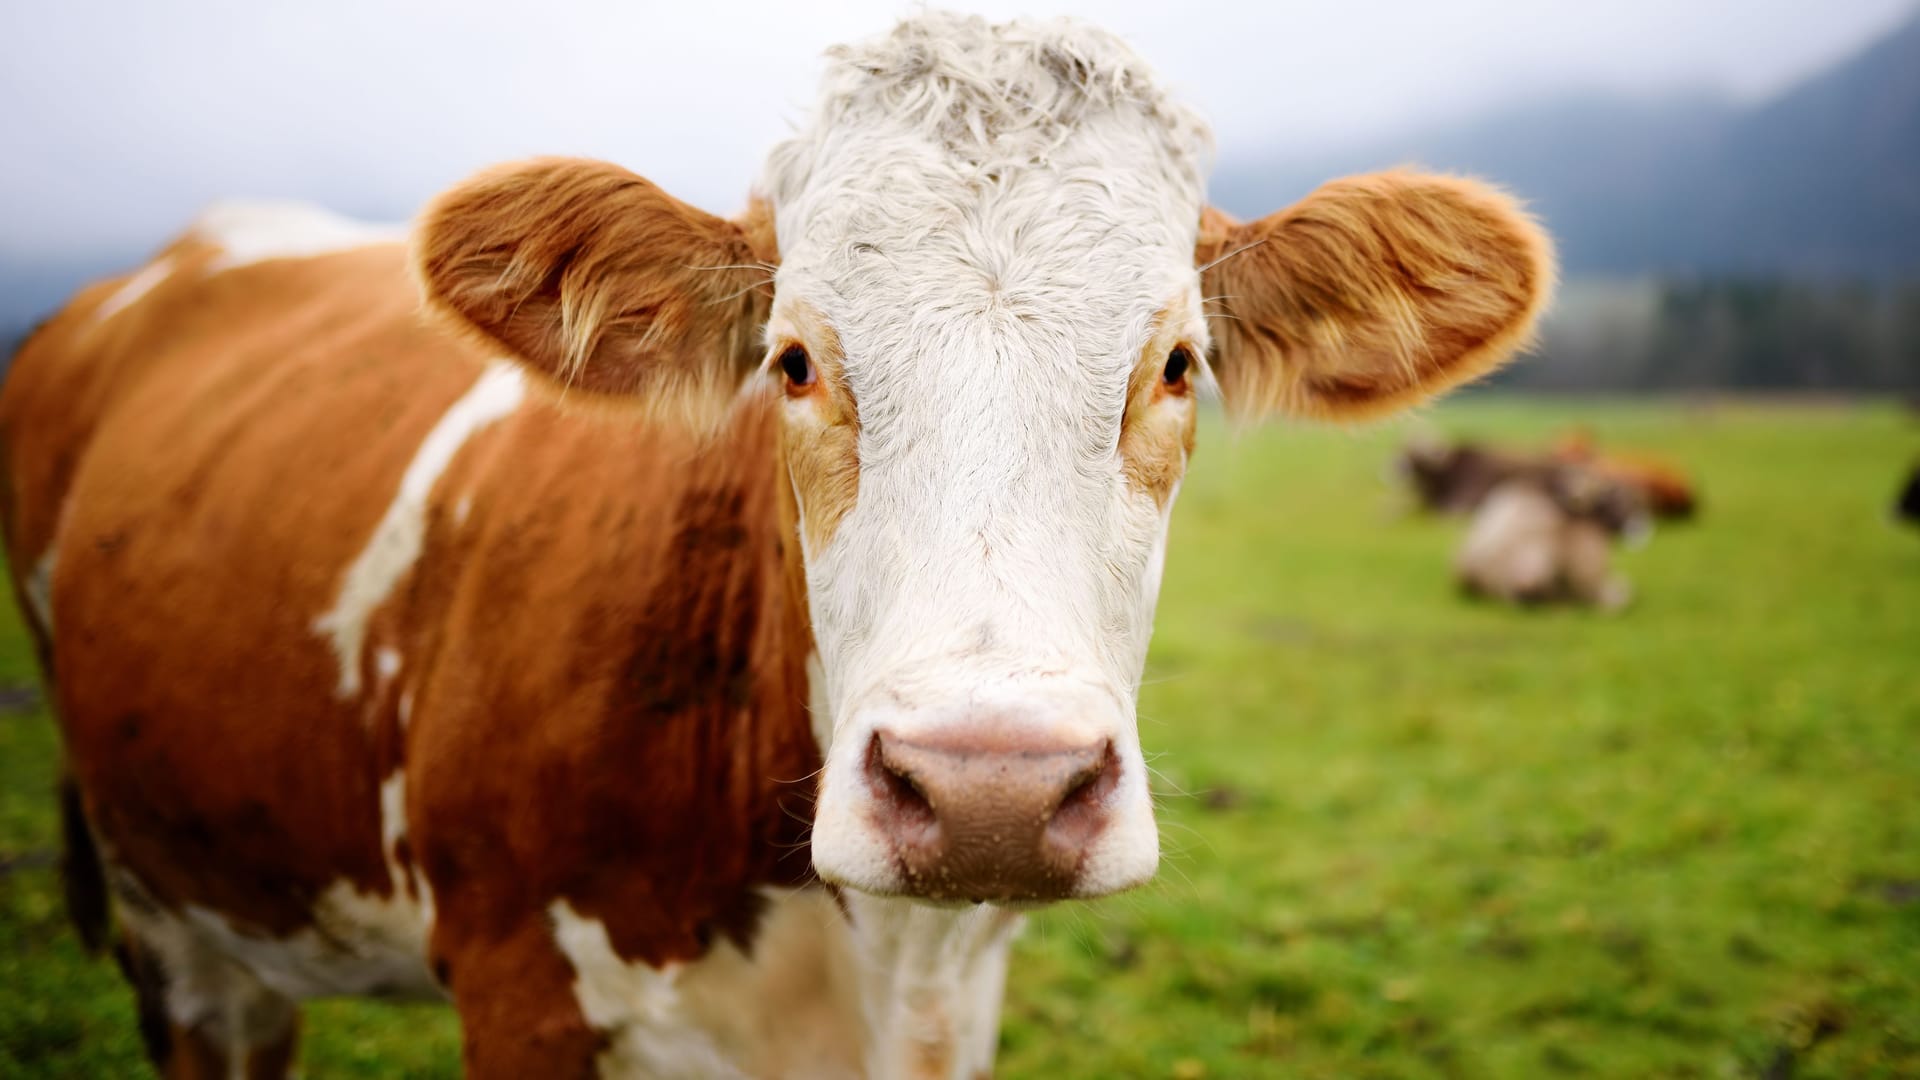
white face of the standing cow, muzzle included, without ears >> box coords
[764,19,1208,897]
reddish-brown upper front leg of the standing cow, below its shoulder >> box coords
[434,915,605,1080]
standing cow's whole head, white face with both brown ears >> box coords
[417,15,1553,901]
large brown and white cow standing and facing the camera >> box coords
[0,15,1553,1076]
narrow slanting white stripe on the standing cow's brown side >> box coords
[313,359,526,698]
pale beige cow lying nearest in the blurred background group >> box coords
[1453,465,1647,611]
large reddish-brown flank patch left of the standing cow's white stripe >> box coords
[29,246,449,934]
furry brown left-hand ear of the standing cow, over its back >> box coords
[413,158,778,404]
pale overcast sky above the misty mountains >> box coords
[0,0,1916,256]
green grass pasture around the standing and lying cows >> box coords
[0,398,1920,1078]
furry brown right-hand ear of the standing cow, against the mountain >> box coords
[1194,171,1553,419]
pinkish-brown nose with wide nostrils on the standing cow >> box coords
[866,730,1119,901]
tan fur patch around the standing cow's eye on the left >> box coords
[768,302,860,550]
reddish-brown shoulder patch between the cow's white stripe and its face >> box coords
[409,390,820,960]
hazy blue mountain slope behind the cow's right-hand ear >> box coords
[1212,17,1920,279]
